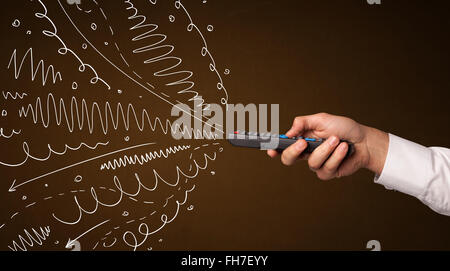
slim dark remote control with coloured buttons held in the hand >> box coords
[228,131,355,158]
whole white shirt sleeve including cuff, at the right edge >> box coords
[375,134,450,215]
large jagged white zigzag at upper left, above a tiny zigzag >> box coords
[5,47,62,86]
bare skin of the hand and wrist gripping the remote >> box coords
[267,113,389,180]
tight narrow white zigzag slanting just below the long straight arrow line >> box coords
[100,145,191,170]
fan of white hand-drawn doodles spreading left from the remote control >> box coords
[0,0,225,251]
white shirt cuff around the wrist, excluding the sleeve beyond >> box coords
[374,134,432,200]
